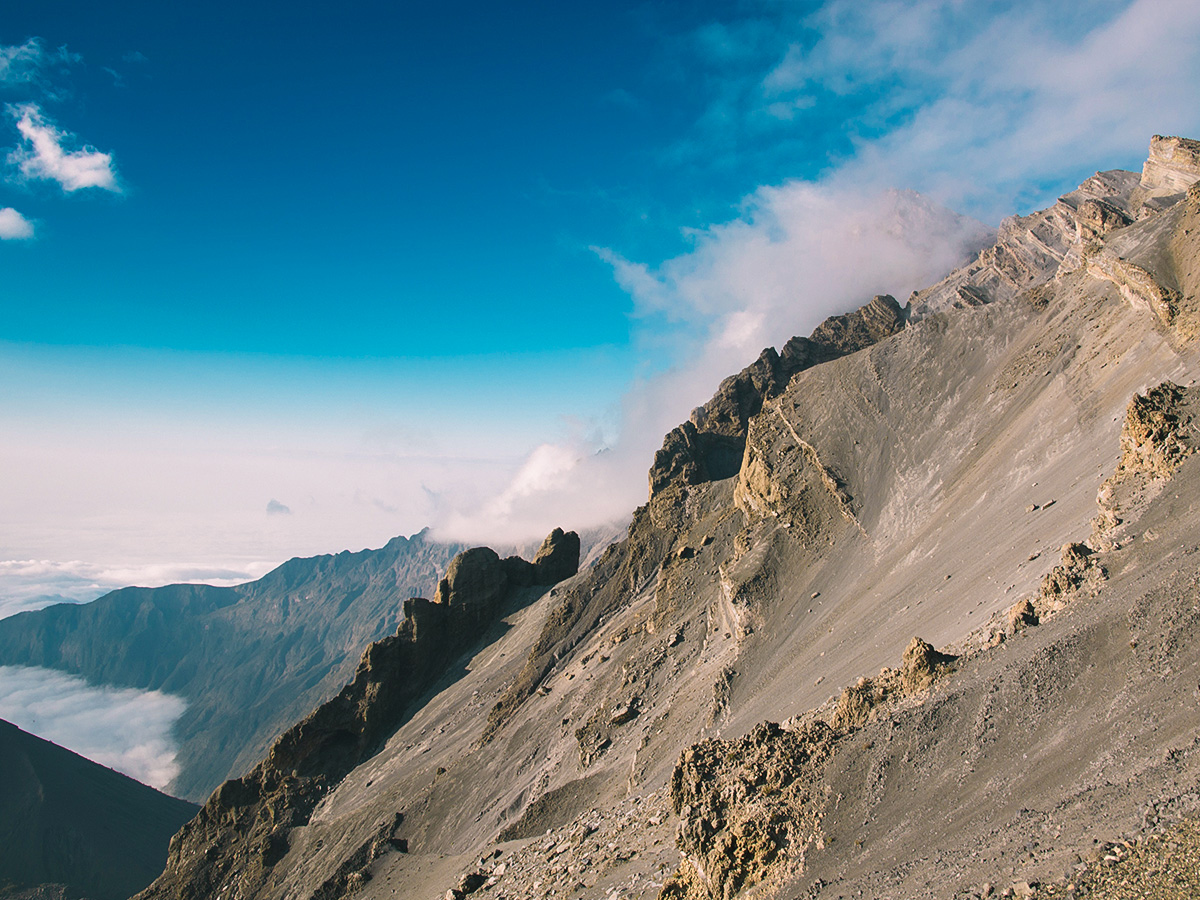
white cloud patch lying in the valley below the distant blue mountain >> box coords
[0,666,187,788]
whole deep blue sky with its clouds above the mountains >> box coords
[0,0,1200,602]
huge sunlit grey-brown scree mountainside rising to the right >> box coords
[126,138,1200,900]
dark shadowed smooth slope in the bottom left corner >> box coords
[0,721,197,900]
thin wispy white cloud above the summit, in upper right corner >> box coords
[761,0,1200,217]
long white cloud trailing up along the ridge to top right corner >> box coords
[437,0,1200,541]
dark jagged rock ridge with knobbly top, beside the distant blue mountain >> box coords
[140,530,580,900]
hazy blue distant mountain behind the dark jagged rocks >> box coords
[0,532,462,799]
